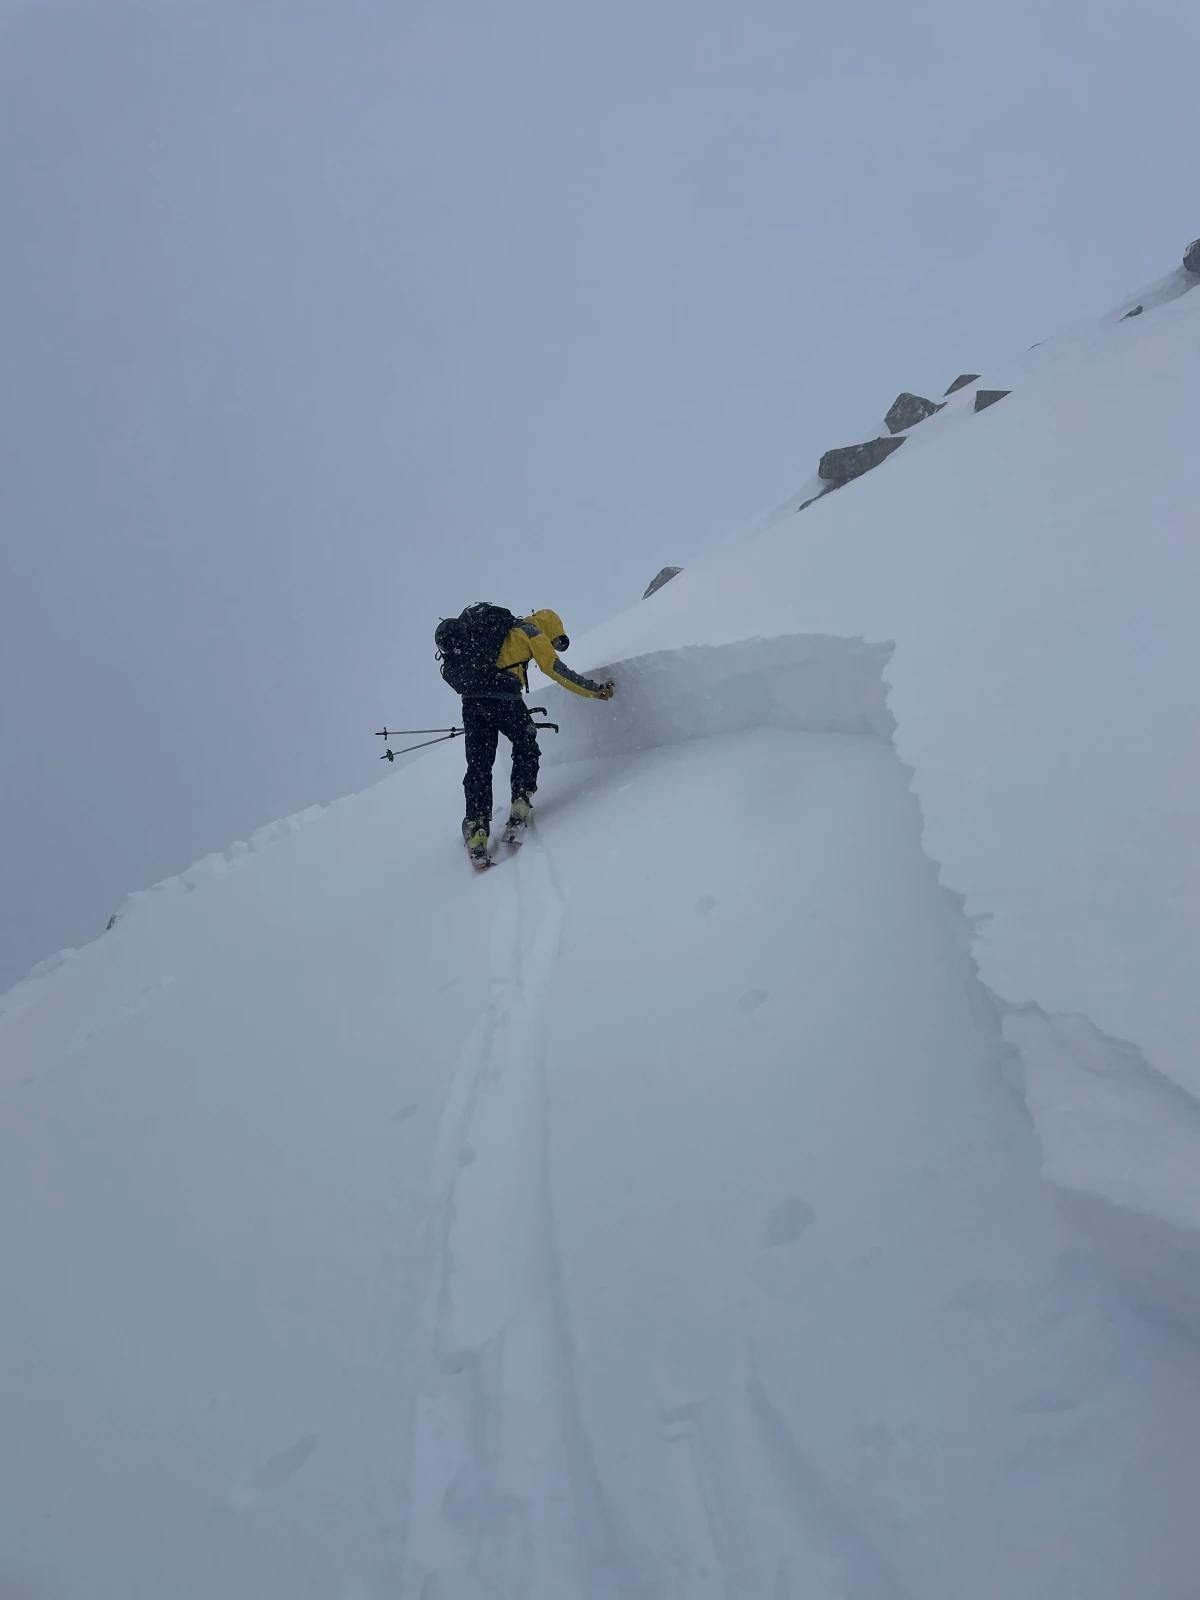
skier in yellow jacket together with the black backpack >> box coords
[435,603,613,867]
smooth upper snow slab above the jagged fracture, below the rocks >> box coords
[579,250,1200,1267]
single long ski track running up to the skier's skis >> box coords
[402,838,640,1600]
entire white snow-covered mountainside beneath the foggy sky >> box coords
[0,274,1200,1600]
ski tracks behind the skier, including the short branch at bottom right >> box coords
[400,812,909,1600]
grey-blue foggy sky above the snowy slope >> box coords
[0,0,1200,987]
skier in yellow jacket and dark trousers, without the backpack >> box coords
[462,611,613,866]
